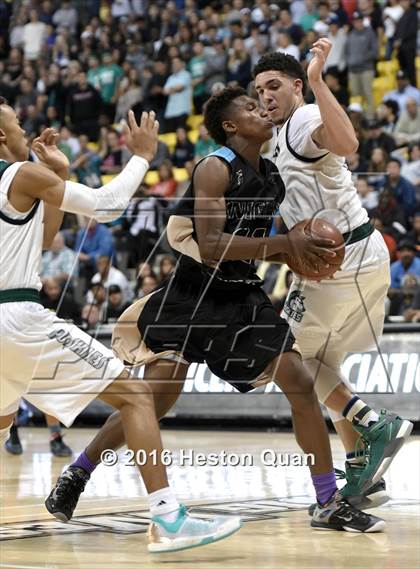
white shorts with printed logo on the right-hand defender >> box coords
[282,231,390,359]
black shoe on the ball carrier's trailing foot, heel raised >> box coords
[45,466,90,522]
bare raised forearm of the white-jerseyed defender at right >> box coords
[311,79,359,156]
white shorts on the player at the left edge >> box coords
[0,302,124,426]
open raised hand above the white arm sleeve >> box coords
[124,111,159,162]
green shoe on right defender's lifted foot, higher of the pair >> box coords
[352,409,413,494]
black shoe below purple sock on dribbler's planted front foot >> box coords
[311,490,385,533]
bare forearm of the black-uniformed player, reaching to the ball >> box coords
[200,233,290,261]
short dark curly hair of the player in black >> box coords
[204,87,247,146]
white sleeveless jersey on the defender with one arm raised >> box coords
[272,105,368,233]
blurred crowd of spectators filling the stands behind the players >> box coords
[0,0,420,326]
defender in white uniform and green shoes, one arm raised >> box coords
[254,38,413,509]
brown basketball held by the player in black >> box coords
[287,217,345,280]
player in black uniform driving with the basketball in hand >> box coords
[46,88,385,533]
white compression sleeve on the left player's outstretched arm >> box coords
[60,156,149,222]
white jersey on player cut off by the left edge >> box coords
[0,160,44,290]
